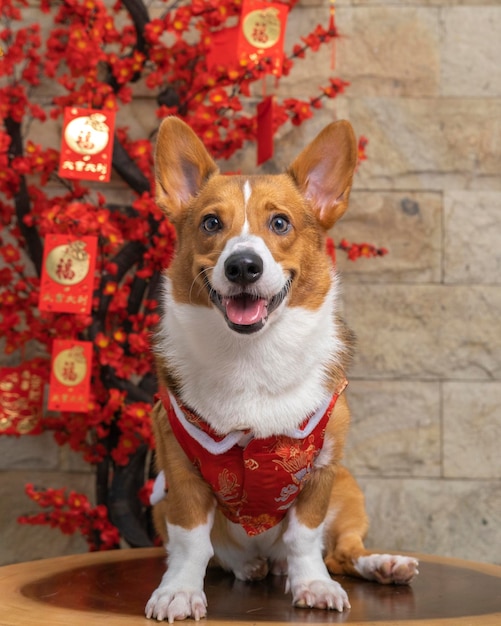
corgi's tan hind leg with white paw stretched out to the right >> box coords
[325,467,418,584]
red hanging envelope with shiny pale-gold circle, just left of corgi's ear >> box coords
[59,107,115,182]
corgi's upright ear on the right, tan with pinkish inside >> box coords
[288,120,358,230]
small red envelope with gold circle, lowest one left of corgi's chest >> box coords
[48,339,92,413]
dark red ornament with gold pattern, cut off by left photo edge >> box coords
[0,358,49,435]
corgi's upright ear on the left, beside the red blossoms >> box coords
[155,117,218,222]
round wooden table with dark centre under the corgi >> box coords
[0,548,501,626]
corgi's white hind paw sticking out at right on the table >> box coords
[354,554,419,585]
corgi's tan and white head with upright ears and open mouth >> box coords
[155,117,357,334]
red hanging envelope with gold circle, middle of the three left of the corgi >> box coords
[38,234,97,315]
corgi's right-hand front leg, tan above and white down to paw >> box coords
[283,468,350,611]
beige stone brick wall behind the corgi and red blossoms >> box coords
[0,0,501,563]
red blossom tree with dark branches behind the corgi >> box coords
[0,0,379,547]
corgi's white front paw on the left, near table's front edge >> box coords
[145,586,207,624]
